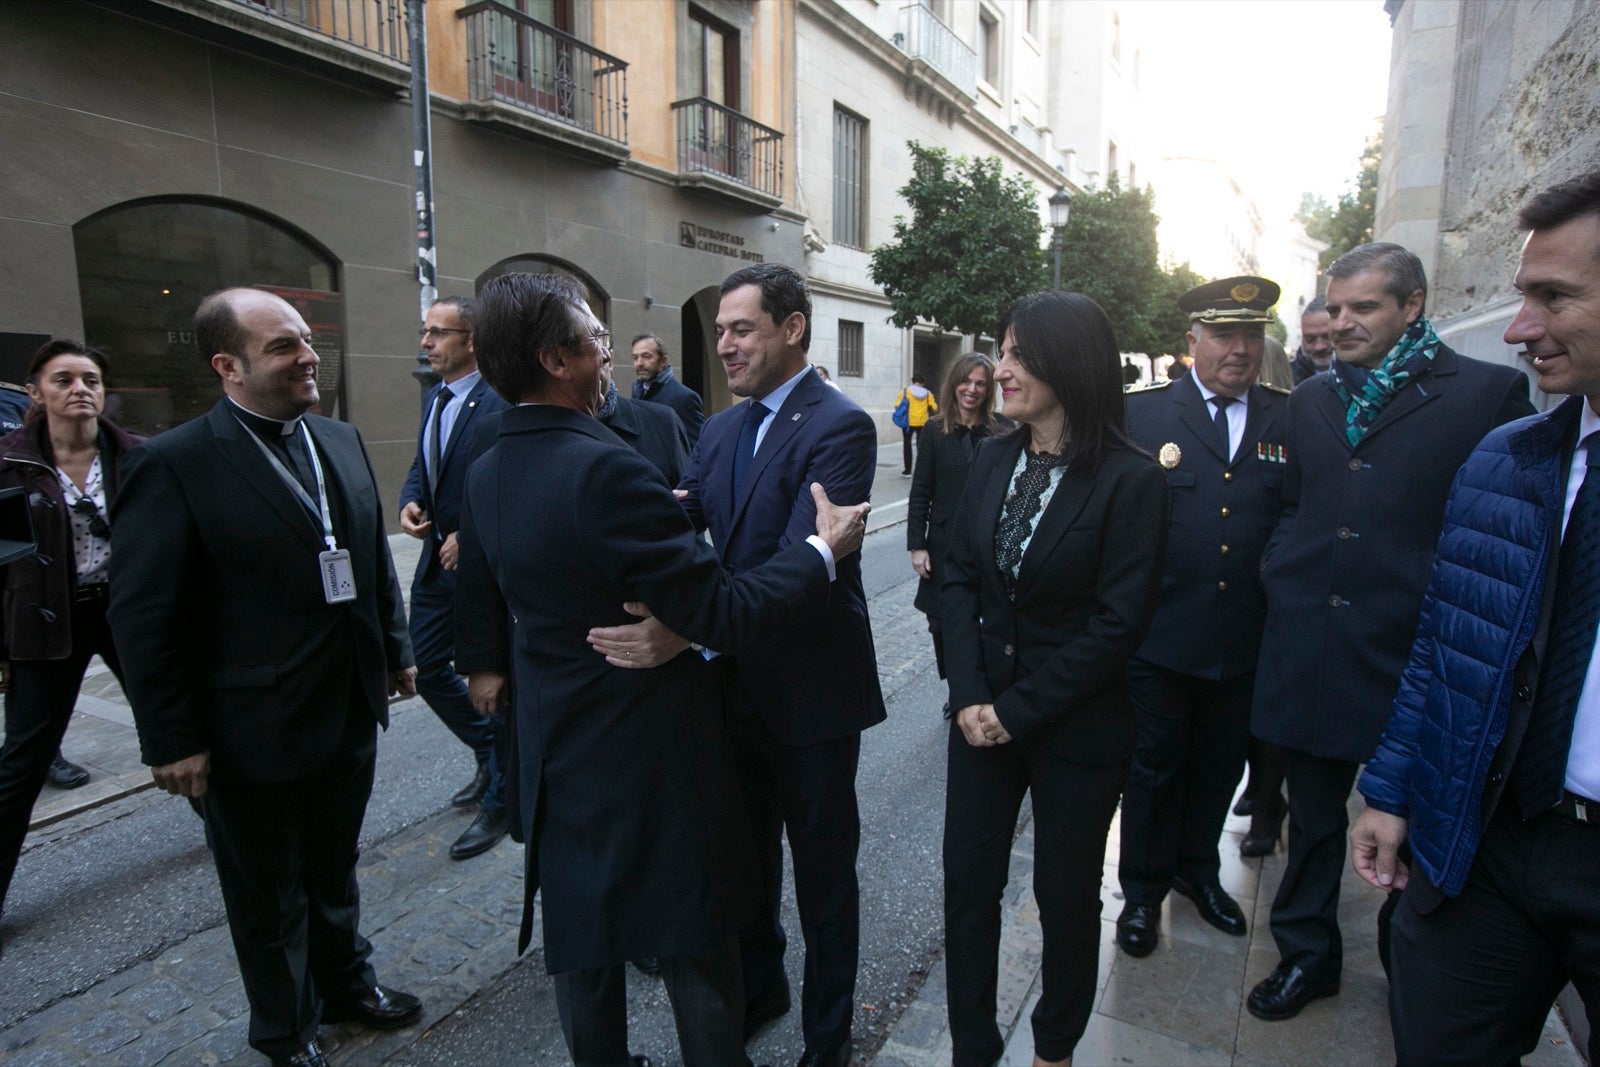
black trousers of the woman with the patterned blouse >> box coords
[944,723,1128,1067]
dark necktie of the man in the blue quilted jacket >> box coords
[1512,434,1600,819]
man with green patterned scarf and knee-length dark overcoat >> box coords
[1246,243,1533,1021]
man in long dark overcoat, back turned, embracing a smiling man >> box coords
[458,275,866,1067]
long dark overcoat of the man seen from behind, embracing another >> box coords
[458,405,827,974]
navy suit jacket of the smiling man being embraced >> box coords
[680,371,885,745]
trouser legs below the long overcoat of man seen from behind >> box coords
[554,934,750,1067]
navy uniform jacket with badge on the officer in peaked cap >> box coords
[1128,374,1290,681]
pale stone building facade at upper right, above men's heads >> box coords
[1373,0,1600,403]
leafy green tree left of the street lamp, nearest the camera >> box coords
[872,141,1046,334]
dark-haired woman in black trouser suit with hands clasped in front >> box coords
[941,293,1166,1067]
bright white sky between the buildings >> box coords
[1122,0,1390,218]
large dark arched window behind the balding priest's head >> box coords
[72,197,344,434]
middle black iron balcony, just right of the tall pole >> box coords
[456,0,629,163]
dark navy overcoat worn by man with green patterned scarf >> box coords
[1251,346,1533,763]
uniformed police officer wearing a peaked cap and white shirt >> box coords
[1117,277,1288,957]
